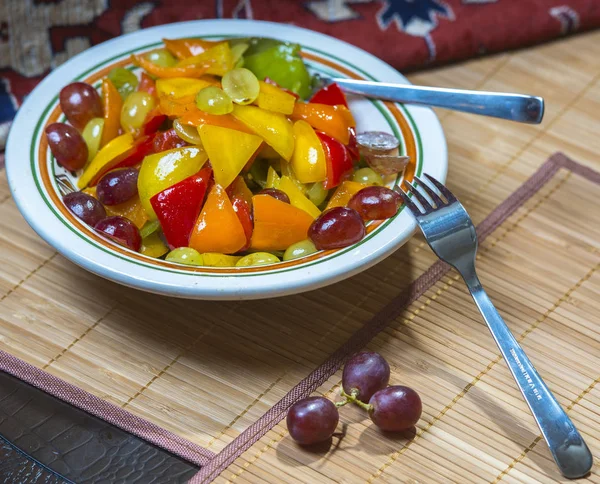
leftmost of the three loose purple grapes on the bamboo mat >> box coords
[286,397,340,445]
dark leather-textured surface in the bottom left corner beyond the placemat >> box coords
[0,372,198,484]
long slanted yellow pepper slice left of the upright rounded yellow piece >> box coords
[231,105,294,161]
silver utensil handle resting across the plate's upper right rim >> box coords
[332,79,544,124]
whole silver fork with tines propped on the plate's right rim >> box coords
[398,175,593,479]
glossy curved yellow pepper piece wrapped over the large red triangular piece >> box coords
[138,146,208,220]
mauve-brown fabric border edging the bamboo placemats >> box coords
[0,153,600,484]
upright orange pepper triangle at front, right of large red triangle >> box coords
[190,183,246,254]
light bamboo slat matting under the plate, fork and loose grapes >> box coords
[0,33,600,482]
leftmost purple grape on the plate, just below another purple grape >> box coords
[45,123,88,171]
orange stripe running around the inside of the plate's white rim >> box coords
[38,52,417,274]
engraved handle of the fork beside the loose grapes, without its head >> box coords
[461,267,593,479]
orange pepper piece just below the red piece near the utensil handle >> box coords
[291,103,356,145]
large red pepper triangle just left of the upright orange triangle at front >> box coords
[150,167,212,249]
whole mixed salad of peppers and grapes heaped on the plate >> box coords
[45,38,407,267]
